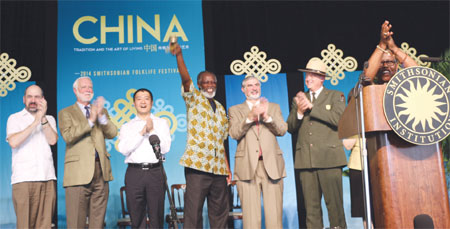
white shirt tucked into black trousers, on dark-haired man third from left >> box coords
[118,114,172,163]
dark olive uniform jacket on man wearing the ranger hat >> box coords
[287,88,347,169]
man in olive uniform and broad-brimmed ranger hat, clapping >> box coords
[287,58,347,228]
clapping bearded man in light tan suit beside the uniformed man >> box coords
[228,76,287,228]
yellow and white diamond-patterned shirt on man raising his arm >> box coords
[180,81,228,175]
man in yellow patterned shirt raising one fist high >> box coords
[172,44,231,228]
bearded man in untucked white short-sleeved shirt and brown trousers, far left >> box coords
[6,85,58,228]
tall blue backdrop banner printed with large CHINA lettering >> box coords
[57,0,206,227]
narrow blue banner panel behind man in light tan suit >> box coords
[225,74,298,228]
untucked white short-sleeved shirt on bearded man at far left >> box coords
[6,108,57,184]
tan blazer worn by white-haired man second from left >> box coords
[58,103,117,187]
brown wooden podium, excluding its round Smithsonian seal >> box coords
[363,85,450,228]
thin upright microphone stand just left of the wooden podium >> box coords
[353,71,372,229]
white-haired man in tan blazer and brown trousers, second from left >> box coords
[58,77,117,228]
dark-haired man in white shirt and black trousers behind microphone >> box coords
[118,88,171,228]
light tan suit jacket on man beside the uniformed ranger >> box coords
[228,102,287,180]
